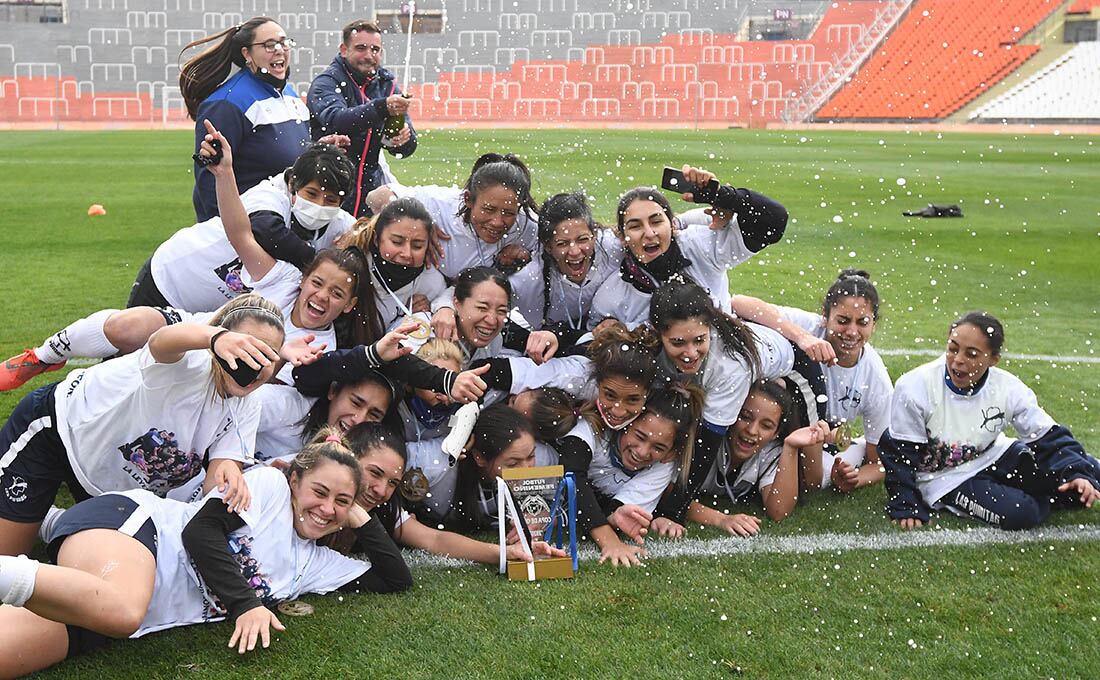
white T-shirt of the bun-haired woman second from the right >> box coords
[779,307,893,445]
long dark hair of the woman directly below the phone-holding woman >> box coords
[649,282,760,375]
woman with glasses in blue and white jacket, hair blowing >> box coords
[179,17,348,222]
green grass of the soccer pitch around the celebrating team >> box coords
[0,125,1100,678]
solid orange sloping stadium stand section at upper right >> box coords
[815,0,1063,120]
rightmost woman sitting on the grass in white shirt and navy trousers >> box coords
[879,311,1100,529]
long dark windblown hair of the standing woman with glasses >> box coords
[179,17,278,120]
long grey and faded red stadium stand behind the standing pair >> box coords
[0,0,909,124]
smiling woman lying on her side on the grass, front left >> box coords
[0,429,413,677]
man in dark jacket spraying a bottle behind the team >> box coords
[308,20,416,217]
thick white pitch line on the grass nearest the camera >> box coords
[406,525,1100,568]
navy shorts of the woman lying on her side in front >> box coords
[46,493,156,657]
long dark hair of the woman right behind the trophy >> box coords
[447,404,535,530]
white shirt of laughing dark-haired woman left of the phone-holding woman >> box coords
[508,229,623,330]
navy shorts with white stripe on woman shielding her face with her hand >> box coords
[0,383,91,524]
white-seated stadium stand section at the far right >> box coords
[970,42,1100,122]
